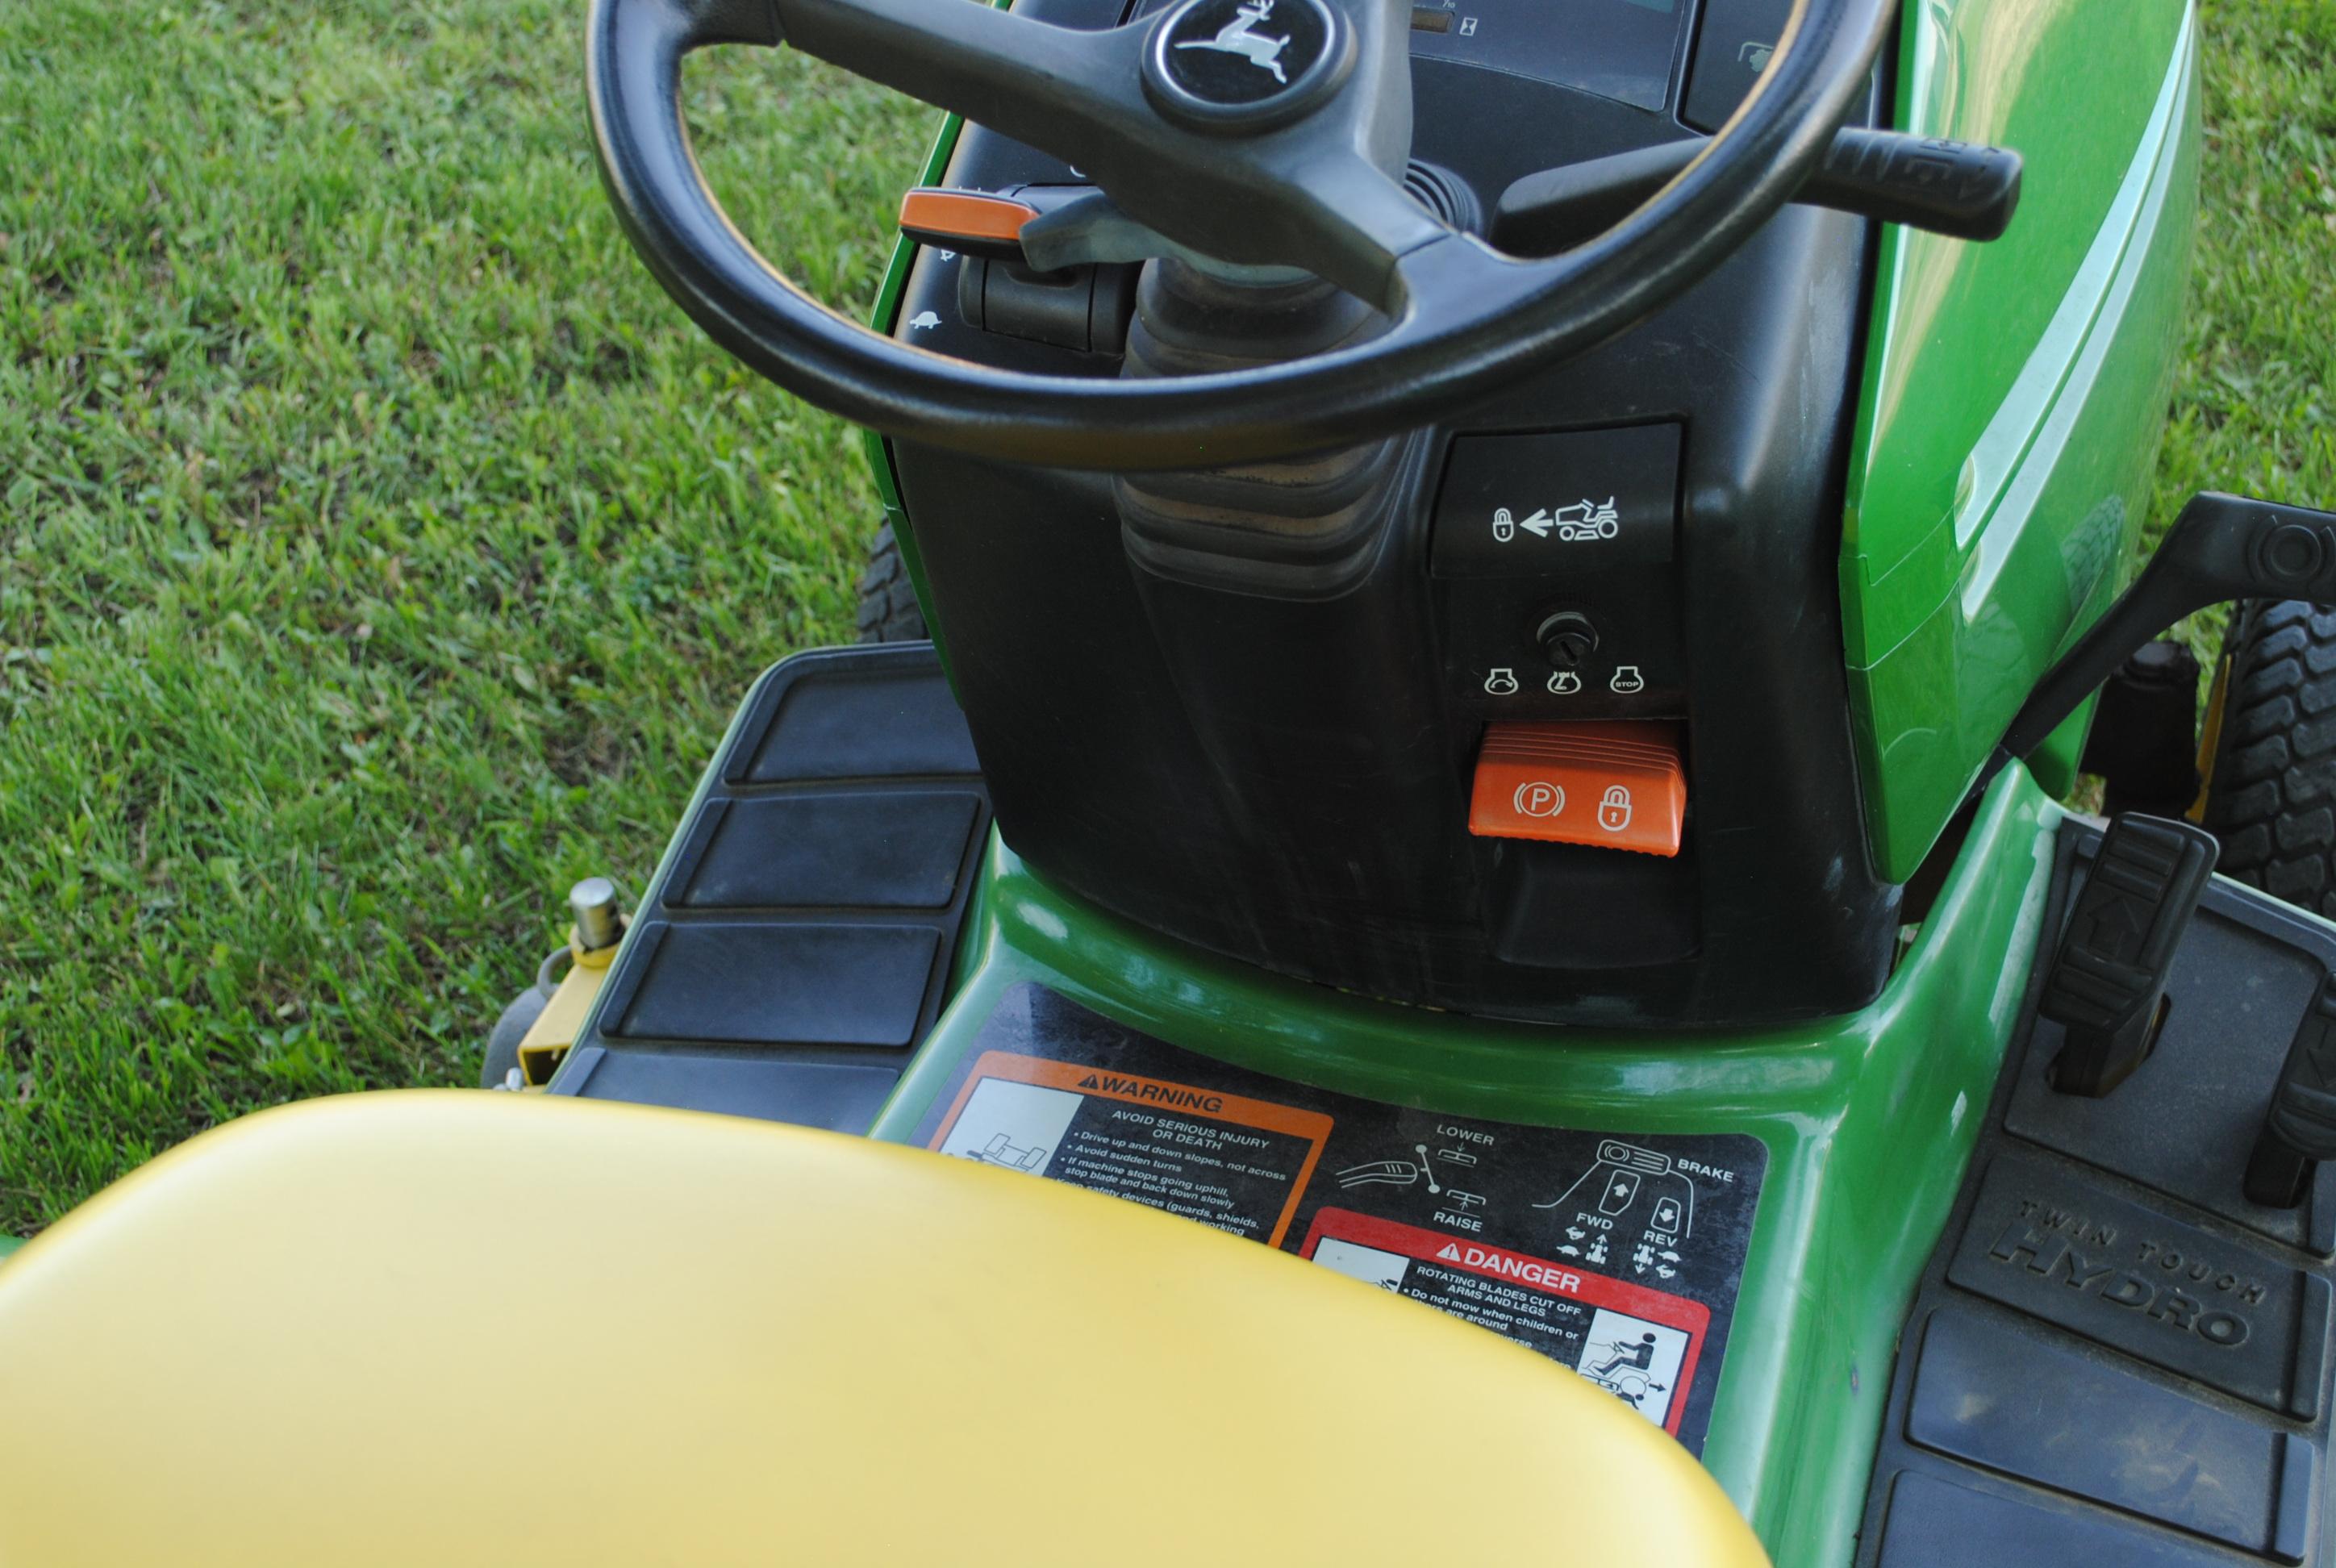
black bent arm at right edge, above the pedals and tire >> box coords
[1981,490,2336,761]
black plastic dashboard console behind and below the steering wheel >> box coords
[892,0,1897,1028]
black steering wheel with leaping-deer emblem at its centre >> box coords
[586,0,1895,469]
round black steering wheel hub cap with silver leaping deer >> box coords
[1145,0,1355,131]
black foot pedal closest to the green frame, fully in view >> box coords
[2037,815,2219,1099]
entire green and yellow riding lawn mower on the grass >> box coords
[0,0,2336,1568]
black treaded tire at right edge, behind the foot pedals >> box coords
[2205,598,2336,916]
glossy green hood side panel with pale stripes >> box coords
[1841,0,2200,881]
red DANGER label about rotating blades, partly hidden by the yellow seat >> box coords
[1299,1208,1712,1435]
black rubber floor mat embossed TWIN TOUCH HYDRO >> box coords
[1857,823,2336,1568]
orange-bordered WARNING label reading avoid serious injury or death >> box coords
[928,1052,1332,1245]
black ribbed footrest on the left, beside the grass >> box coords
[551,643,991,1131]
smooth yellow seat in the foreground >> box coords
[0,1091,1766,1568]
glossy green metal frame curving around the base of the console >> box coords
[874,769,2063,1566]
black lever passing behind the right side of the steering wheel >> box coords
[1488,128,2021,257]
